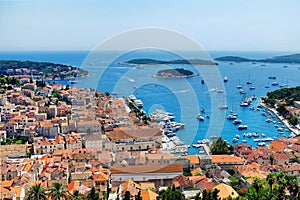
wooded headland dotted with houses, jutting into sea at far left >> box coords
[0,60,89,80]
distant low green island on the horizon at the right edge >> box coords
[215,53,300,64]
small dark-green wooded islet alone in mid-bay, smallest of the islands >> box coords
[152,68,199,78]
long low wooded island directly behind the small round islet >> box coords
[120,58,218,65]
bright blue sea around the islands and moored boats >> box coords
[0,49,300,154]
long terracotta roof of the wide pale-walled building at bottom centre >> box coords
[110,164,183,174]
